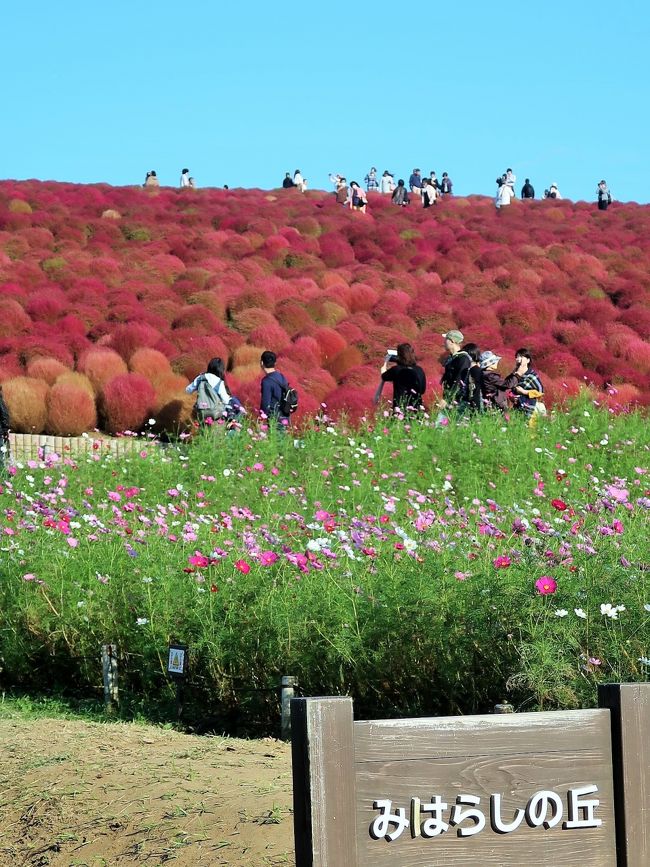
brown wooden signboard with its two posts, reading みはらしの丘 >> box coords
[291,684,650,867]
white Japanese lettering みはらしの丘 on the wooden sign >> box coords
[370,785,602,842]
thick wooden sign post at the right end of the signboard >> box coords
[598,683,650,867]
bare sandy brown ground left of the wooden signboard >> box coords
[0,720,295,867]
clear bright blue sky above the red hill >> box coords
[5,0,650,202]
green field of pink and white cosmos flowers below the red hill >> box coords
[0,406,650,730]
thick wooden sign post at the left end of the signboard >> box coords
[291,698,358,867]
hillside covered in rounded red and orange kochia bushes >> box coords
[0,181,650,434]
